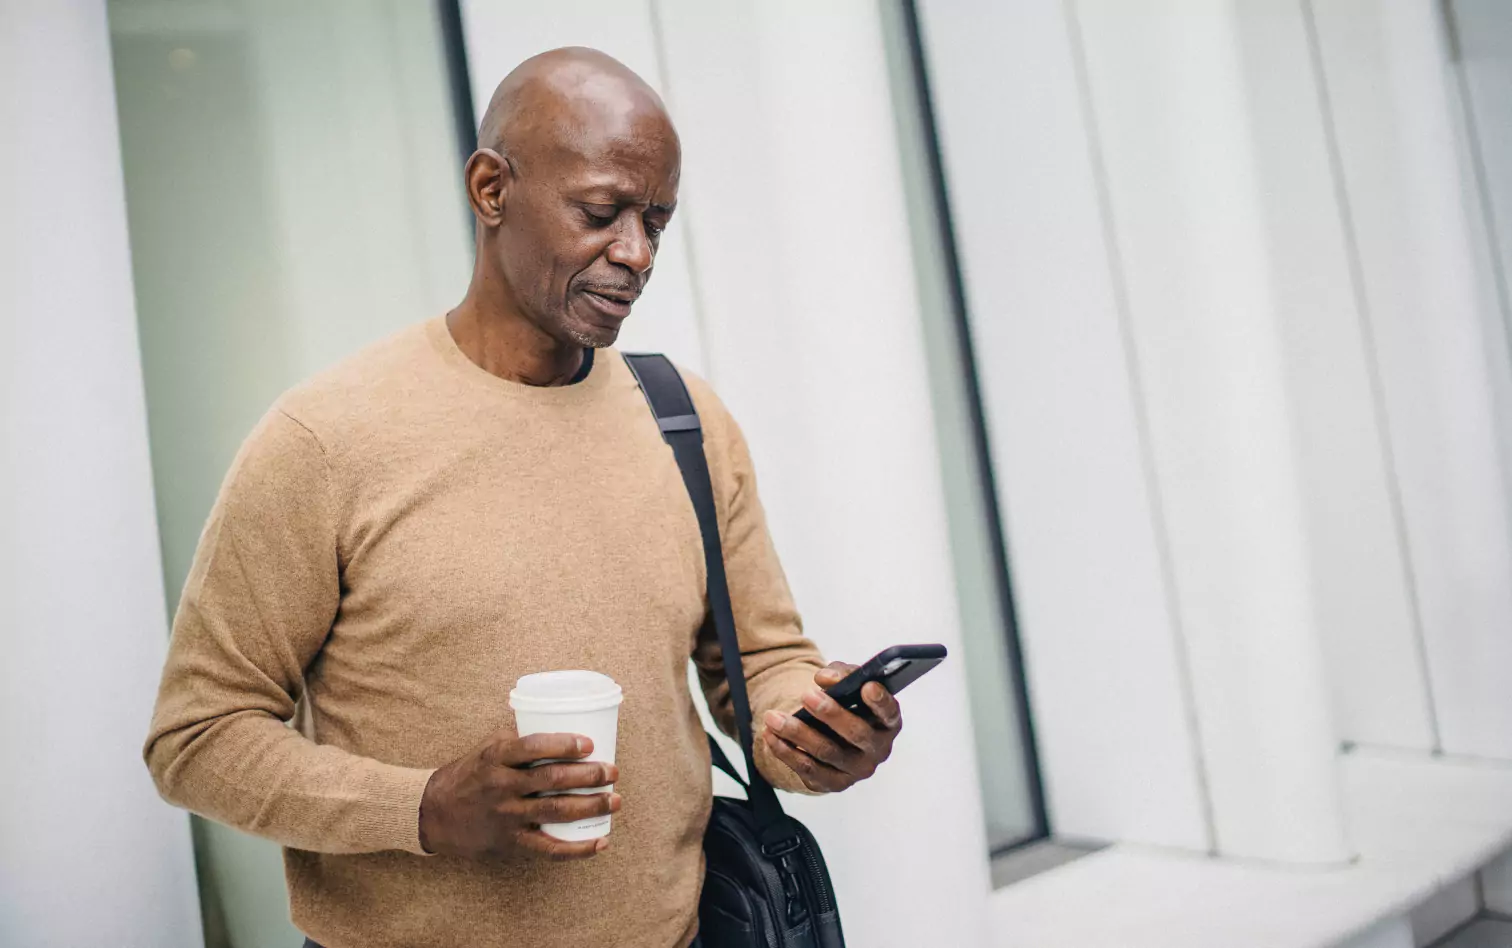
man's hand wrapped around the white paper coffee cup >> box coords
[420,732,620,859]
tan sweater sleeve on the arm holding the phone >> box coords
[689,378,824,794]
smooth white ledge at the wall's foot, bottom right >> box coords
[989,750,1512,948]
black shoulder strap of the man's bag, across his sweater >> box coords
[624,352,794,844]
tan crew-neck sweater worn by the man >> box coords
[145,319,823,948]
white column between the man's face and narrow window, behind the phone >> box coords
[656,0,1013,948]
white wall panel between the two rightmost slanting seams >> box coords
[1314,0,1512,757]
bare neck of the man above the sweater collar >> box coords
[446,293,584,386]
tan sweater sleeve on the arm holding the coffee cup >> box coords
[145,408,432,853]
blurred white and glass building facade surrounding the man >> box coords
[0,0,1512,948]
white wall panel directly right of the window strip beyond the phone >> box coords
[901,0,1213,850]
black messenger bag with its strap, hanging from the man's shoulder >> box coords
[624,354,845,948]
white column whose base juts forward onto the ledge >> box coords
[1070,0,1366,863]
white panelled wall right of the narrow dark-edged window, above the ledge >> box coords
[921,0,1512,862]
